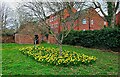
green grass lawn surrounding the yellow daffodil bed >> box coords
[0,43,119,75]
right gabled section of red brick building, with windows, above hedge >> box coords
[74,7,107,30]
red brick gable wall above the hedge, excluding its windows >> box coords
[71,9,105,30]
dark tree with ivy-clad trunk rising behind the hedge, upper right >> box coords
[93,0,120,27]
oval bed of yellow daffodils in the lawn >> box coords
[20,46,96,66]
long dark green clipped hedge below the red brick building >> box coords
[63,28,120,51]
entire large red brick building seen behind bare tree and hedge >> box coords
[47,7,107,43]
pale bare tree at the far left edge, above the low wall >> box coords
[0,2,18,35]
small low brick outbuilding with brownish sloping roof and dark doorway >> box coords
[15,22,46,44]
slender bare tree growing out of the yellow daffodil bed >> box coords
[17,0,85,56]
